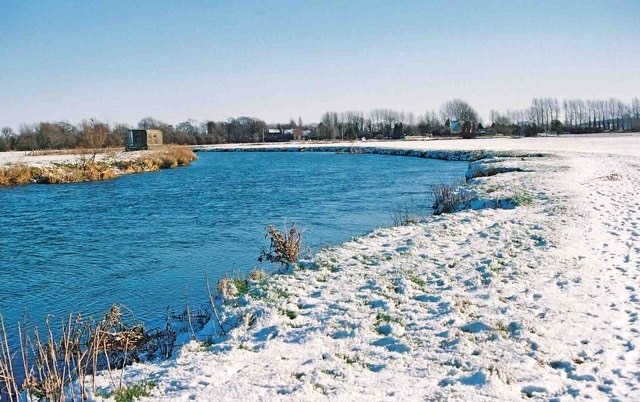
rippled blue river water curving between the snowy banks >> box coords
[0,152,467,327]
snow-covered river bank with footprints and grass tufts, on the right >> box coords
[89,136,640,400]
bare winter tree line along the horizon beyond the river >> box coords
[0,98,640,151]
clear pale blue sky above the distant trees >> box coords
[0,0,640,129]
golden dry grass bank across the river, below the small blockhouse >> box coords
[0,147,197,186]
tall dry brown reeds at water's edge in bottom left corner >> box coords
[0,305,175,402]
